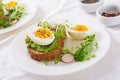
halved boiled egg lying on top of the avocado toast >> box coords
[27,27,55,45]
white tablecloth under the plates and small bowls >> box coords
[0,0,120,80]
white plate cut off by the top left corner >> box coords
[0,0,37,34]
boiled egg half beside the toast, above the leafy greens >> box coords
[68,25,88,40]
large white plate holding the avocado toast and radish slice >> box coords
[10,23,110,76]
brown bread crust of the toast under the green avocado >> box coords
[27,38,64,61]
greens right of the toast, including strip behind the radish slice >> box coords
[62,34,98,62]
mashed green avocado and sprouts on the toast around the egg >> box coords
[25,22,65,52]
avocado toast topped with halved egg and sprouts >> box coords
[25,22,66,61]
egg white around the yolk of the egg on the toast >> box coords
[27,27,55,45]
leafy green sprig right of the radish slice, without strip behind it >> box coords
[74,34,98,62]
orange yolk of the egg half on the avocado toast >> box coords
[34,28,51,38]
